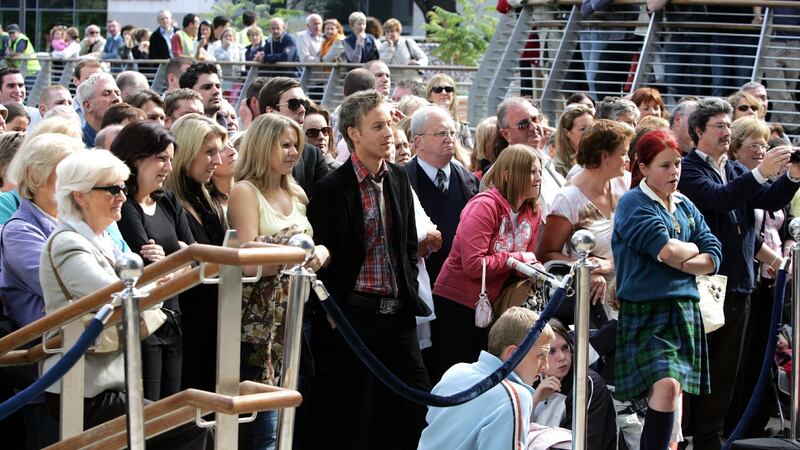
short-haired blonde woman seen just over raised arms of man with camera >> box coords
[728,115,794,436]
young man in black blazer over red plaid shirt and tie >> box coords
[308,90,431,449]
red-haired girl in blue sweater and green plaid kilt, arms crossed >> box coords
[611,131,722,450]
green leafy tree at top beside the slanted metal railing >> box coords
[425,0,498,66]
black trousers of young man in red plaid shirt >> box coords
[313,302,431,450]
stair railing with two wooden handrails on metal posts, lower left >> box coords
[0,230,307,448]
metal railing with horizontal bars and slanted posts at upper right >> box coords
[468,0,800,139]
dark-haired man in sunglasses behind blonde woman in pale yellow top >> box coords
[253,77,329,198]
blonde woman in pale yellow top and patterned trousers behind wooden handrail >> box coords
[228,113,328,448]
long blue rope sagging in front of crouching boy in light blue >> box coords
[320,282,565,407]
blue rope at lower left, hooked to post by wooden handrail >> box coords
[0,305,113,420]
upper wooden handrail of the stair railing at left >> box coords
[0,244,306,359]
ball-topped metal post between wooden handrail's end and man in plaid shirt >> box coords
[276,234,317,450]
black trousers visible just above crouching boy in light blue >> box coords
[425,295,489,386]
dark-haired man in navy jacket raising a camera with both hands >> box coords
[678,97,800,450]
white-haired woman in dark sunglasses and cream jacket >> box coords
[39,149,213,450]
